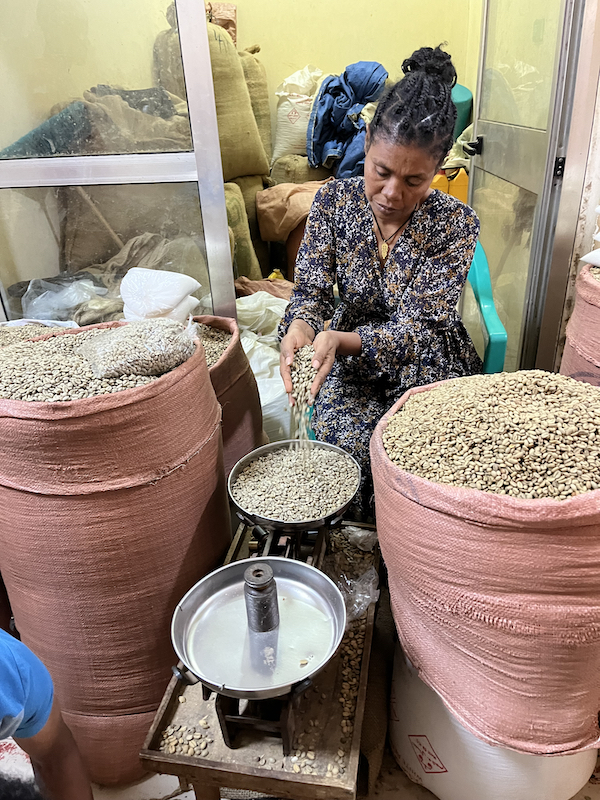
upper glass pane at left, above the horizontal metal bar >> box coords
[0,0,192,158]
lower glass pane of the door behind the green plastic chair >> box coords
[462,169,537,371]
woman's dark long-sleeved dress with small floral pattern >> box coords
[279,177,482,515]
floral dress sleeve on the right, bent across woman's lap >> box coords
[354,204,479,381]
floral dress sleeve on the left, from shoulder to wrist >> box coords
[279,181,336,338]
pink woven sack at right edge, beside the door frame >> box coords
[560,264,600,386]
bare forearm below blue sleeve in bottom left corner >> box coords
[15,698,93,800]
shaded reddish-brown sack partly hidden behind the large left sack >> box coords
[194,315,265,477]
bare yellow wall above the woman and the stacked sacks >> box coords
[237,0,482,126]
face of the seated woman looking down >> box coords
[365,134,438,226]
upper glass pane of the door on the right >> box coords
[480,0,562,130]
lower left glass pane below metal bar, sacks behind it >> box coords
[0,183,212,325]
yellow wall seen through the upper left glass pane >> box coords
[0,0,169,148]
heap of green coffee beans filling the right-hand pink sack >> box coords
[383,370,600,500]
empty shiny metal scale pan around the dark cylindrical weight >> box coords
[171,557,346,699]
